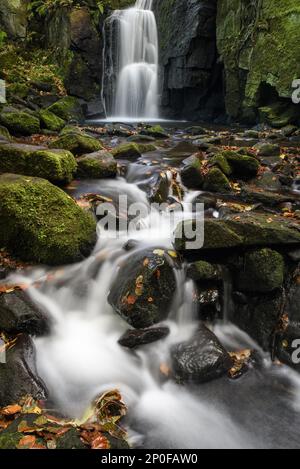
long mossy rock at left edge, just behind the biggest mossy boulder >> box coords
[0,143,77,184]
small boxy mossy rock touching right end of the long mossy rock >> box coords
[77,150,117,179]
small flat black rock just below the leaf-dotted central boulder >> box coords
[119,327,170,349]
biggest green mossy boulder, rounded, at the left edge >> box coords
[0,174,96,265]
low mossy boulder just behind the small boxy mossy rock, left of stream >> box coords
[49,133,103,156]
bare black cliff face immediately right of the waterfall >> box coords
[154,0,224,120]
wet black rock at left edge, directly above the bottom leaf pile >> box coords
[0,335,47,407]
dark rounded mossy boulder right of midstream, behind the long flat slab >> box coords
[221,151,260,180]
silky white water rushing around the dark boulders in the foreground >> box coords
[9,176,300,449]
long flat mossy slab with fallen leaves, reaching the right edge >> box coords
[174,213,300,253]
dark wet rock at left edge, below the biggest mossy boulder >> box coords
[0,290,50,336]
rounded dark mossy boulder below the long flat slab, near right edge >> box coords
[236,248,285,293]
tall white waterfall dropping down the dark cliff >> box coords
[104,0,158,119]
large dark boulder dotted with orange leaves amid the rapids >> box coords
[108,249,177,329]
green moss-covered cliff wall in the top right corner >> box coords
[217,0,300,120]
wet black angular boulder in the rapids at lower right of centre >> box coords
[171,325,233,383]
